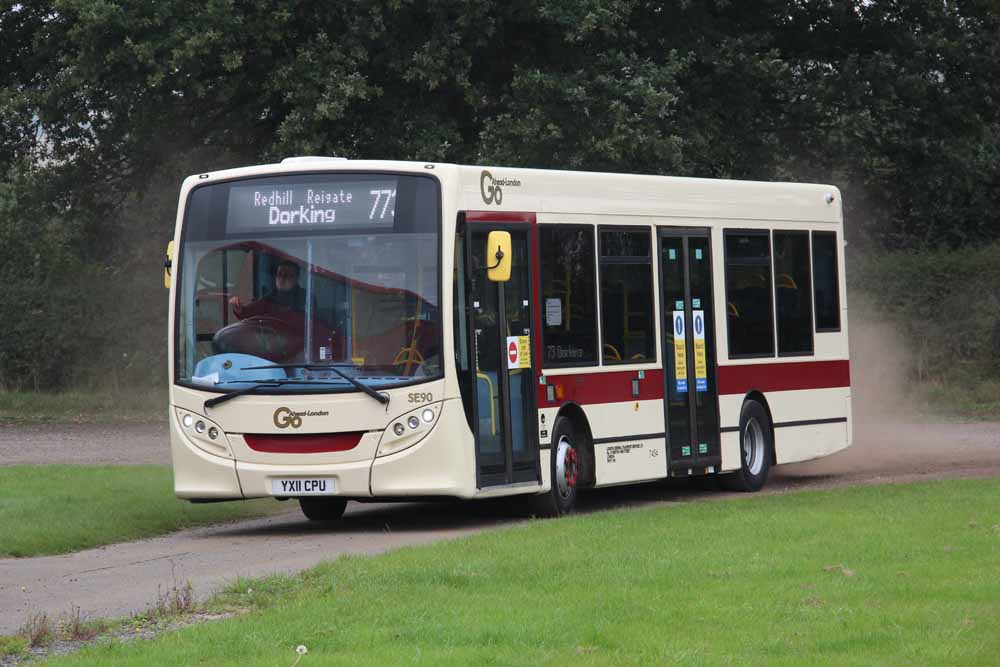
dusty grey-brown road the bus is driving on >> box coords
[0,423,1000,635]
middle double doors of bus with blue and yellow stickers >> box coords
[659,229,722,475]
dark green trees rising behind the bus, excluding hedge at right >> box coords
[0,0,1000,387]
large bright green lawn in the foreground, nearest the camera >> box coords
[43,480,1000,667]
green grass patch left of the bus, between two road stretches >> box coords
[0,465,288,557]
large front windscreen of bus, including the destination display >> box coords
[175,173,442,393]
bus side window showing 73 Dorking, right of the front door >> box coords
[538,225,597,367]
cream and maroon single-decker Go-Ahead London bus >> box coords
[167,157,851,520]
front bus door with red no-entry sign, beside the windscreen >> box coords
[465,223,540,488]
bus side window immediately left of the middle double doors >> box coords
[600,227,656,364]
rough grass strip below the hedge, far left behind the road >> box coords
[0,388,167,423]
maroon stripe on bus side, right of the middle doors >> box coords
[719,359,851,394]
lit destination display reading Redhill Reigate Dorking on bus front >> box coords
[226,179,397,234]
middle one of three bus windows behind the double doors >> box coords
[774,231,813,355]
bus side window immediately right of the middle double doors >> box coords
[725,230,774,357]
